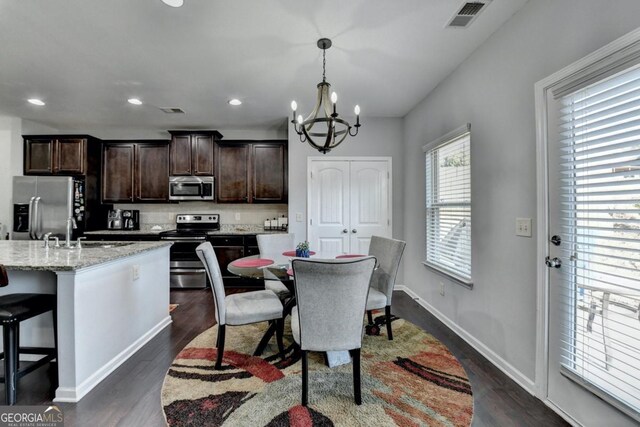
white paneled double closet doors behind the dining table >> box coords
[307,157,392,254]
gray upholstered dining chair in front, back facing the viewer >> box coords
[291,257,376,406]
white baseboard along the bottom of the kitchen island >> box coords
[53,316,172,403]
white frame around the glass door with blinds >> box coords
[534,28,640,424]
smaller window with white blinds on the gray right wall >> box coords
[425,130,471,286]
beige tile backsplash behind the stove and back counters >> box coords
[114,202,289,226]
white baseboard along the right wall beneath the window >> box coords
[395,285,535,396]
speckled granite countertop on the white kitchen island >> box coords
[0,240,171,271]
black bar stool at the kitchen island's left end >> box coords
[0,265,58,405]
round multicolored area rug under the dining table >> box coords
[162,316,473,426]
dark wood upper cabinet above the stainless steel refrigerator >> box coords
[24,135,99,175]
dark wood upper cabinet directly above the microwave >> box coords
[169,130,222,176]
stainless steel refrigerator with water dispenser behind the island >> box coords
[12,176,85,240]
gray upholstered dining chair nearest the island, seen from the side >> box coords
[196,242,284,369]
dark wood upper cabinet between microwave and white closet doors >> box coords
[215,140,288,203]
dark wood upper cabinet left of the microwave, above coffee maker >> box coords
[102,141,169,203]
